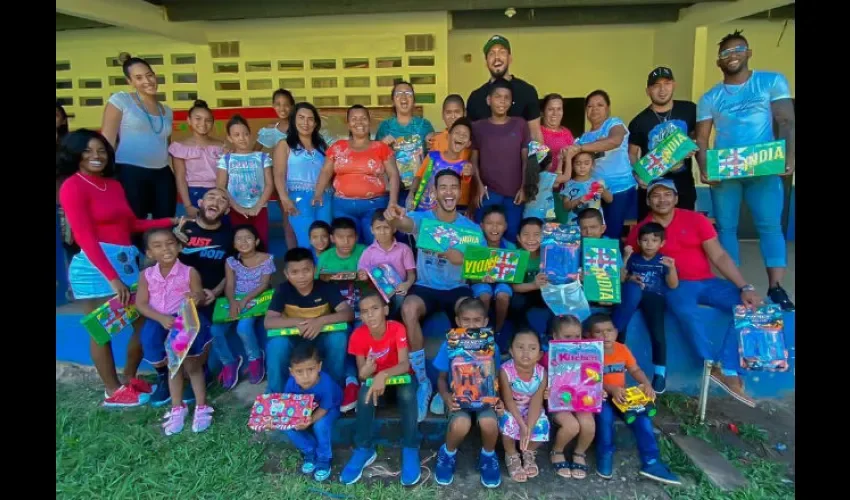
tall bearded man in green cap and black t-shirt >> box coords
[466,35,543,144]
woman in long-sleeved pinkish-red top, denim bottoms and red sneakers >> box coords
[56,129,178,407]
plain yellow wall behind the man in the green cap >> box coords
[448,26,654,129]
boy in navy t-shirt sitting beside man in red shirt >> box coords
[611,222,679,394]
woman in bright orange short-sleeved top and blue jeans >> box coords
[312,104,399,245]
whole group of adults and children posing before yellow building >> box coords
[56,28,794,487]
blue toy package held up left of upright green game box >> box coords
[540,222,581,285]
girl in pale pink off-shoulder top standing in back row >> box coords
[168,100,224,218]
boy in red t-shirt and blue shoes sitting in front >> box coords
[339,291,420,486]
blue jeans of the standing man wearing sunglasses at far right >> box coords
[711,175,787,267]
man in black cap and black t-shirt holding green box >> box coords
[629,66,697,220]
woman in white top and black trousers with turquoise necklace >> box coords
[101,53,172,246]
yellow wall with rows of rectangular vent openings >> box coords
[56,12,448,128]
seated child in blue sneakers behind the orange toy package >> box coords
[431,298,505,488]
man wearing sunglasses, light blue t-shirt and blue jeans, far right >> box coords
[696,31,795,311]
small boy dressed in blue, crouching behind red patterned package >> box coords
[283,342,342,481]
